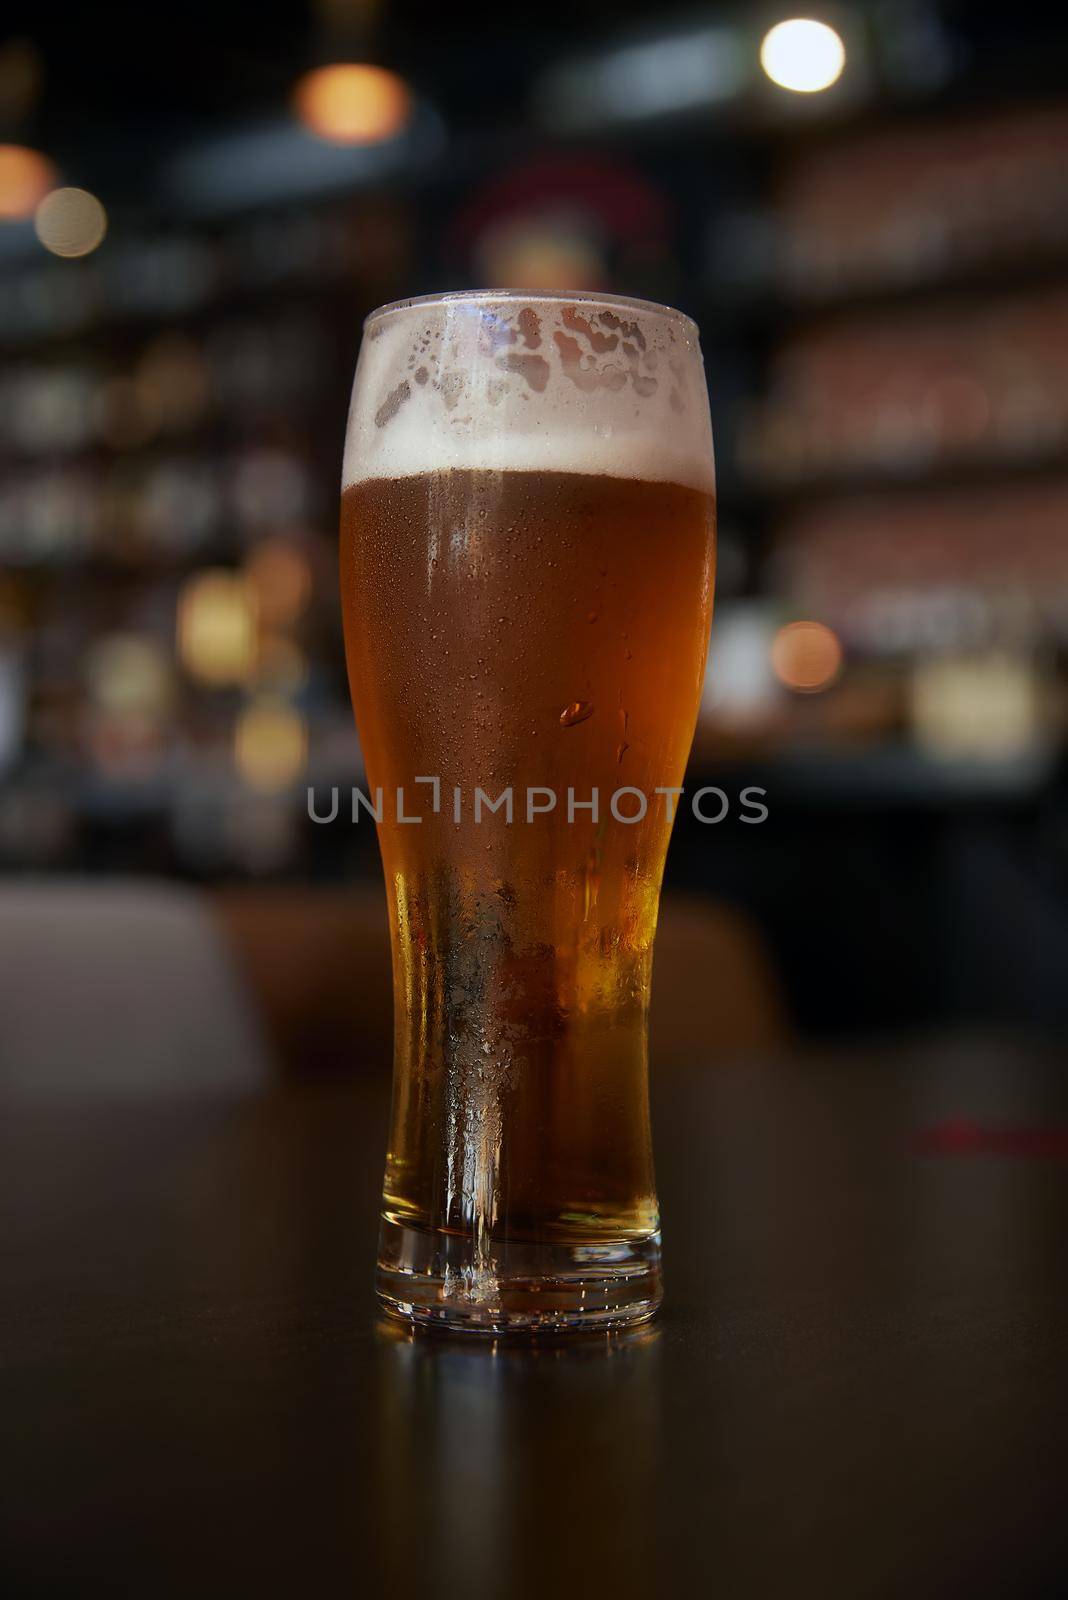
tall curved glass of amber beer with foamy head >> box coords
[341,290,715,1334]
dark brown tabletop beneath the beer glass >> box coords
[0,1042,1068,1600]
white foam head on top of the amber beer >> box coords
[342,293,715,491]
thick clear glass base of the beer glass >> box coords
[376,1218,664,1338]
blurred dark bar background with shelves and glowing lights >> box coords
[0,0,1068,1062]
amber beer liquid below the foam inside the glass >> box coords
[341,470,715,1301]
